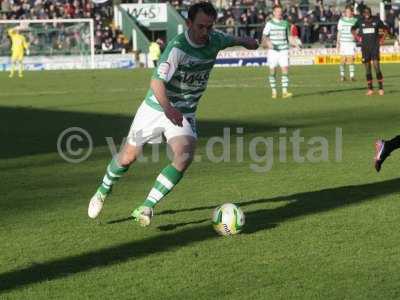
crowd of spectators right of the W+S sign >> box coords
[172,0,400,44]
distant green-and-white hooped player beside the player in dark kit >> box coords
[336,5,357,81]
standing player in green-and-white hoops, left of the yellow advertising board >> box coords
[261,5,297,99]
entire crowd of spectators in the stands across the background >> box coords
[0,0,400,52]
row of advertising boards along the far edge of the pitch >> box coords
[0,46,400,71]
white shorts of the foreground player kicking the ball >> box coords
[127,101,197,146]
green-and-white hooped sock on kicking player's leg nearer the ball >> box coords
[143,165,183,208]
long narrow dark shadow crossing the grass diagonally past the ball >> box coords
[0,179,400,293]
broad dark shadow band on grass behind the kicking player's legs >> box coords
[0,106,304,162]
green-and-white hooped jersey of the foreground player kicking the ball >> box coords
[144,31,235,114]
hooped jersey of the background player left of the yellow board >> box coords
[263,19,290,51]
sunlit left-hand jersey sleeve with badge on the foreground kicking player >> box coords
[152,42,184,82]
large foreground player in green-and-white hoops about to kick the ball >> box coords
[88,2,258,226]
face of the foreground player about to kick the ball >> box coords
[188,11,215,45]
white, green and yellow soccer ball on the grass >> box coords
[212,203,244,235]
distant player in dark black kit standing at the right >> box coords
[352,7,386,96]
